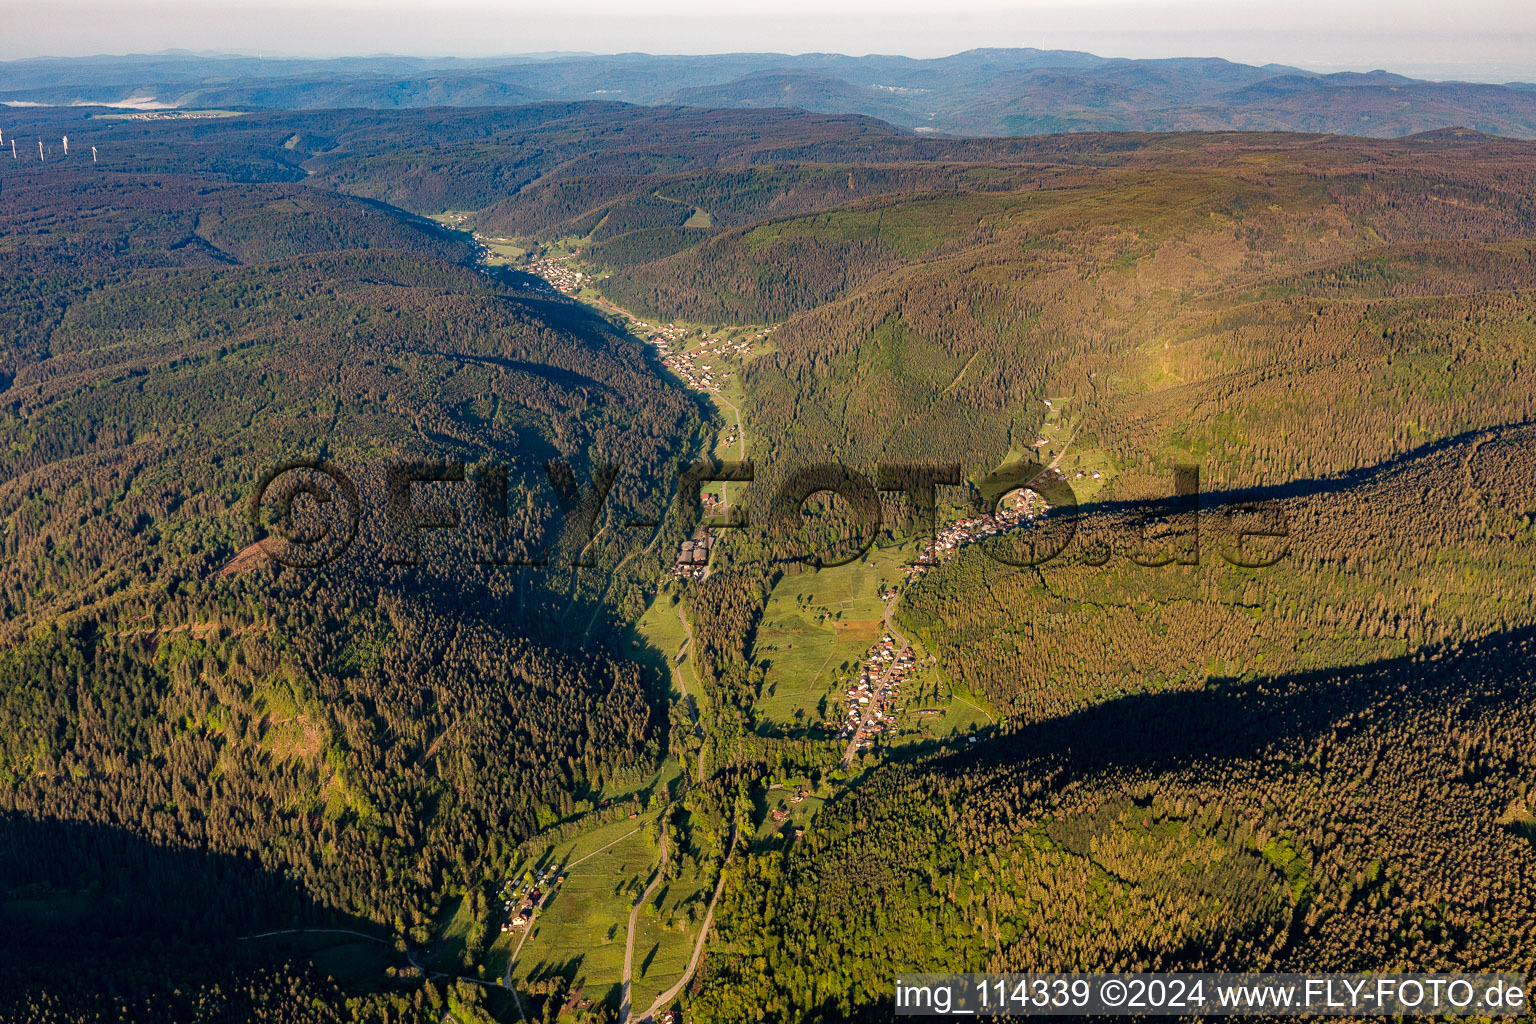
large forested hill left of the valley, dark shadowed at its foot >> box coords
[0,150,703,1021]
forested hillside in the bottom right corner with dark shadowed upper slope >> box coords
[696,629,1536,1022]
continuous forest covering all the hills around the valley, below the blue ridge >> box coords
[0,101,1536,1022]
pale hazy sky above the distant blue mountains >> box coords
[9,0,1536,81]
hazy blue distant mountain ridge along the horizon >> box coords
[9,49,1536,138]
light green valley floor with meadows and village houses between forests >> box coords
[427,228,1098,1021]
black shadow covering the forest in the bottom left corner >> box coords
[0,815,413,1019]
